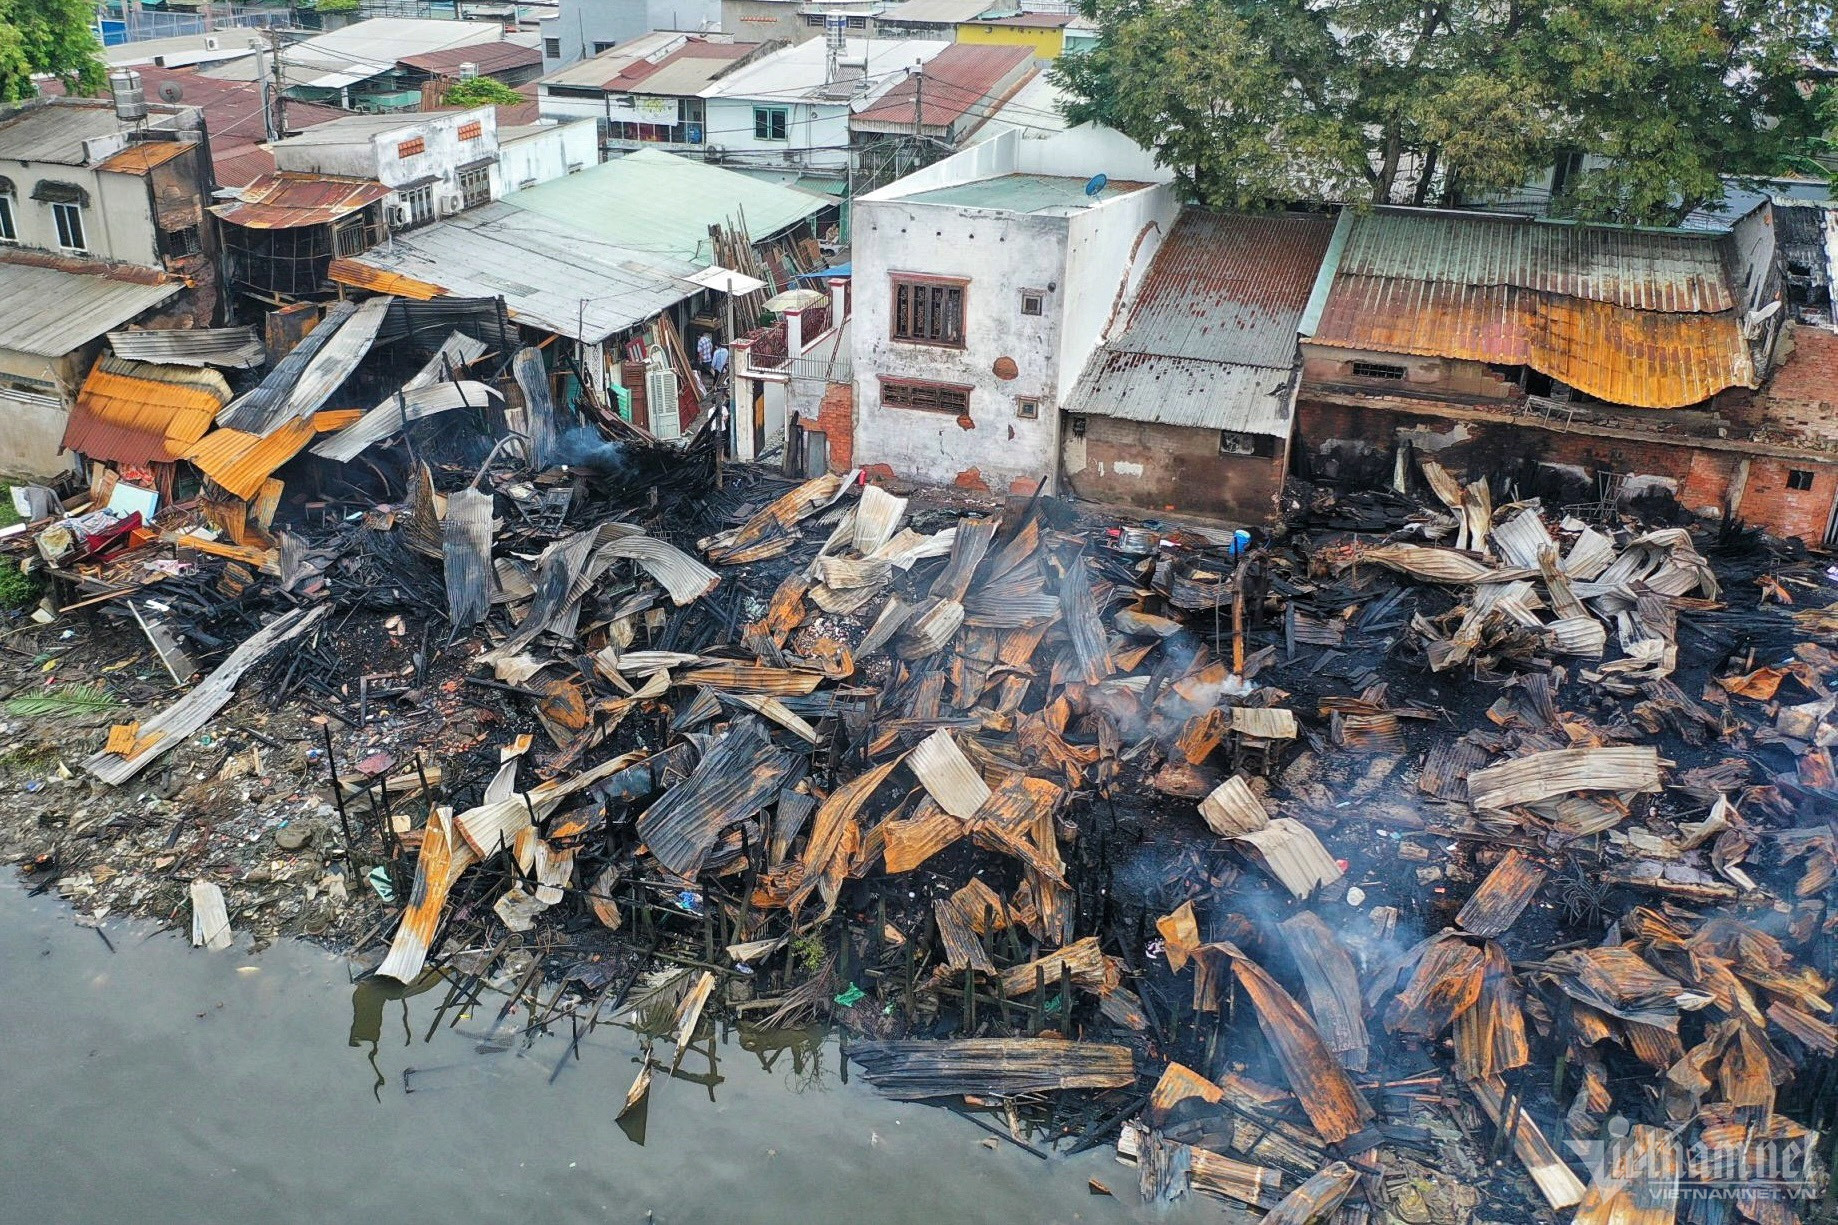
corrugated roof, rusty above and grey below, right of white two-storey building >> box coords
[1066,208,1334,438]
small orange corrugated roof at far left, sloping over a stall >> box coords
[64,357,230,464]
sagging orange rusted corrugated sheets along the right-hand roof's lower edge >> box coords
[1312,274,1755,408]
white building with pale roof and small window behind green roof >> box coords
[704,39,950,175]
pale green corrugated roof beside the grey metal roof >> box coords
[504,149,834,263]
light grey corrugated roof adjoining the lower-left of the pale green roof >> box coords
[341,200,698,344]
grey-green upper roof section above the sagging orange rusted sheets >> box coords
[1338,208,1735,311]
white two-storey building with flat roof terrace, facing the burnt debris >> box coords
[849,127,1178,489]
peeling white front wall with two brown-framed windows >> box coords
[851,199,1077,489]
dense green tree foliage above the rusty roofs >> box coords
[1057,0,1832,223]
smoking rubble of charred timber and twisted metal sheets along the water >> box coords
[9,369,1838,1225]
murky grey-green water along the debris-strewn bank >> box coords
[0,879,1230,1225]
